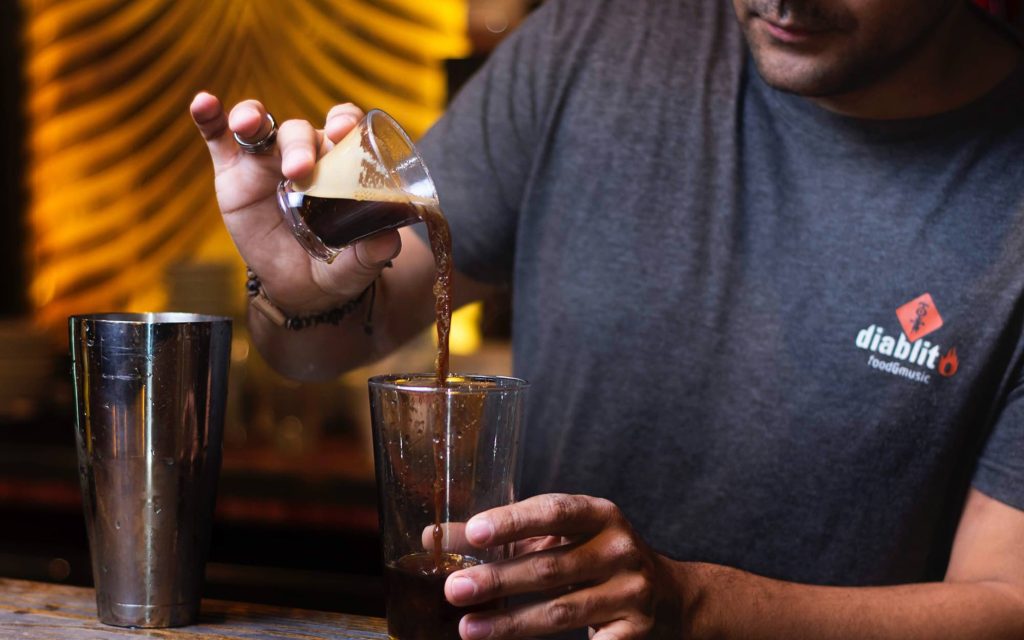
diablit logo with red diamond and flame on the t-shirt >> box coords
[854,293,959,384]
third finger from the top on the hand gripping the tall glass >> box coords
[459,585,637,640]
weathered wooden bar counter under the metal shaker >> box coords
[0,578,387,640]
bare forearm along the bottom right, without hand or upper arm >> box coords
[677,563,1024,640]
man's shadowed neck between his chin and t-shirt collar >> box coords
[809,3,1024,120]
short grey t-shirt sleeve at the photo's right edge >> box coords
[972,380,1024,509]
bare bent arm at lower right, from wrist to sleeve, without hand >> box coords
[678,489,1024,640]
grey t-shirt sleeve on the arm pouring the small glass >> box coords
[417,2,561,283]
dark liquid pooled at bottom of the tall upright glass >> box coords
[384,553,495,640]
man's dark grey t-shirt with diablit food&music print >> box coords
[421,0,1024,585]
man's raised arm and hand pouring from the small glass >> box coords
[189,92,499,380]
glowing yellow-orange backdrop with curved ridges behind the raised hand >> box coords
[22,0,470,332]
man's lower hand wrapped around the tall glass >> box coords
[444,494,683,640]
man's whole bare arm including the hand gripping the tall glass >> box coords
[445,490,1024,640]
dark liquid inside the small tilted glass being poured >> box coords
[299,196,420,249]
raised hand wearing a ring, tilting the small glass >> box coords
[189,92,401,313]
